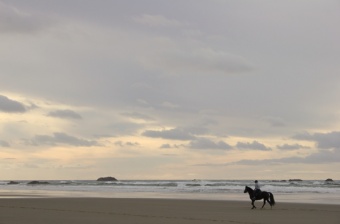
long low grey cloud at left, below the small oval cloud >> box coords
[31,132,99,147]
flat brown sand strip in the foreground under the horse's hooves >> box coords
[0,198,340,224]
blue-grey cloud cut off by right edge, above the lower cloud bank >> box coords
[293,131,340,149]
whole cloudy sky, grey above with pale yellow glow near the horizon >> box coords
[0,0,340,180]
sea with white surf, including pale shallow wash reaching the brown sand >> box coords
[0,180,340,204]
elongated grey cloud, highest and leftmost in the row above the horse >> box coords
[142,128,196,141]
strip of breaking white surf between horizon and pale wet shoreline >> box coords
[0,180,340,194]
